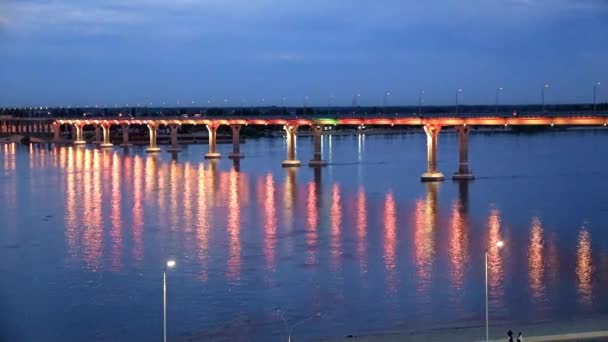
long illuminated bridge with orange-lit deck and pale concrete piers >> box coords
[0,113,608,181]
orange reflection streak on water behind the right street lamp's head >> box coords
[487,209,504,303]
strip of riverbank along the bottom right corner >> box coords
[310,317,608,342]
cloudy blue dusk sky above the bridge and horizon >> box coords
[0,0,608,106]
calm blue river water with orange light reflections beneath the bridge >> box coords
[0,130,608,341]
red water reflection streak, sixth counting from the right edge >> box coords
[383,192,397,290]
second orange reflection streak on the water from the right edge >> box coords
[528,217,545,301]
